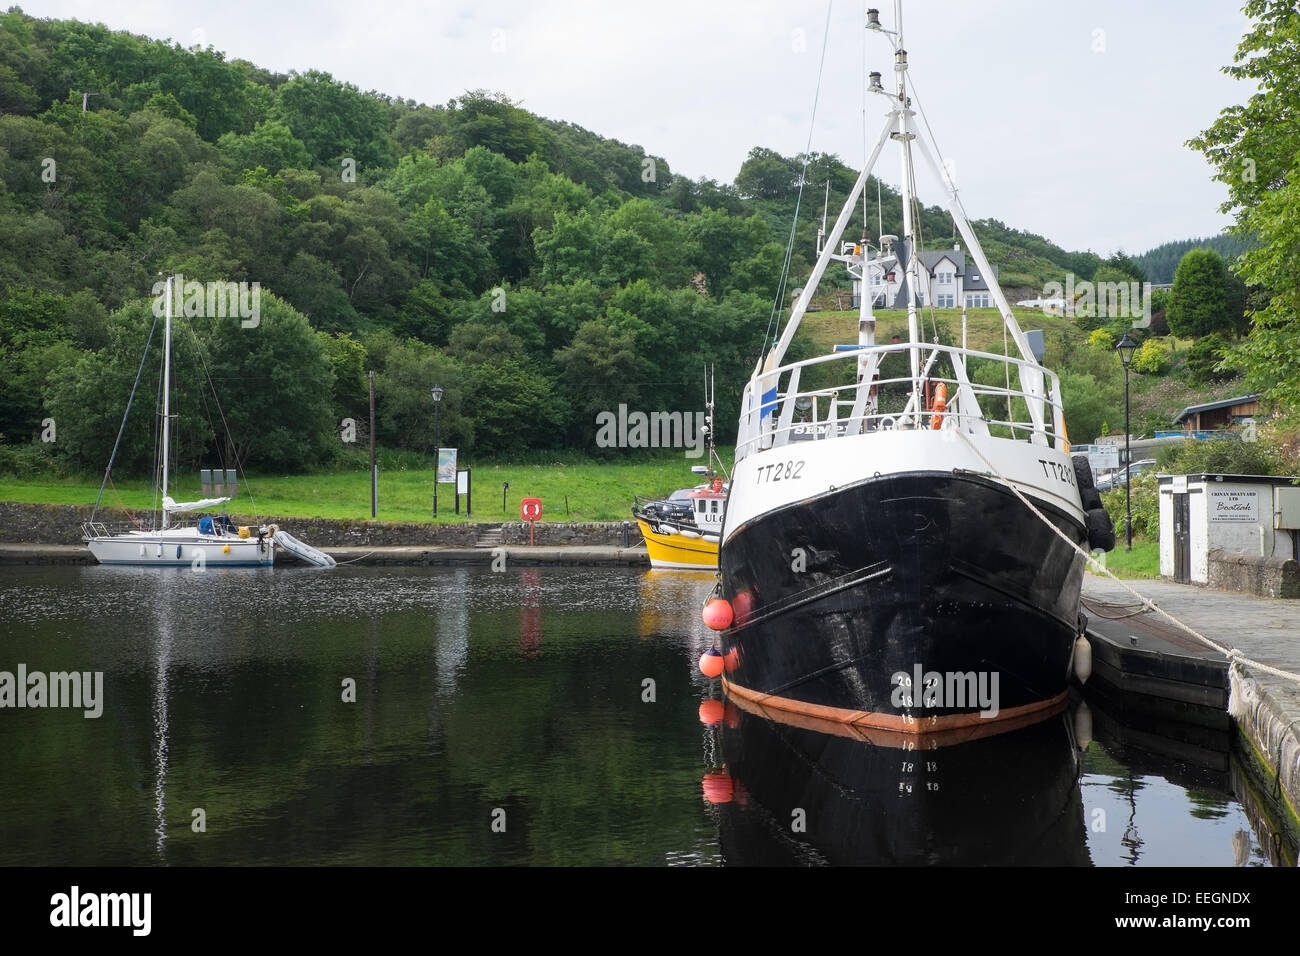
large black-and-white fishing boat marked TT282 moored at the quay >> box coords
[715,0,1114,734]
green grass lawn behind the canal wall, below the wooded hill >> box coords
[0,450,731,522]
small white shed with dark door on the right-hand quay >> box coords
[1158,475,1300,587]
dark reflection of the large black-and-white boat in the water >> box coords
[701,686,1092,866]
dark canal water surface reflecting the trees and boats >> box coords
[0,567,1295,866]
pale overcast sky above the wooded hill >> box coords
[22,0,1252,255]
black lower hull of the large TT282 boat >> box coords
[719,472,1087,732]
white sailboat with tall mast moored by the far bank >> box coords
[82,276,276,568]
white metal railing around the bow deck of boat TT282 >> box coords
[736,342,1069,462]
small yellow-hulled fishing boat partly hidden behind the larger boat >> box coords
[632,378,729,571]
